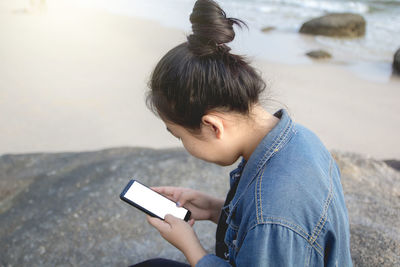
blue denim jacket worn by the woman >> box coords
[196,110,352,267]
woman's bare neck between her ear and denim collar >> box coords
[239,105,279,161]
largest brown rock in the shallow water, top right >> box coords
[300,13,366,38]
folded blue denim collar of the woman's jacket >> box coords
[229,109,295,211]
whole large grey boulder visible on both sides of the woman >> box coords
[0,148,400,266]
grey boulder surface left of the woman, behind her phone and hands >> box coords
[0,148,229,267]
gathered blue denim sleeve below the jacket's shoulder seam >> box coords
[235,224,315,267]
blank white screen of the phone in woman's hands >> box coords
[124,181,187,220]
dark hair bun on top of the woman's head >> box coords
[187,0,246,56]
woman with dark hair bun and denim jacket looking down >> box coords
[130,0,352,267]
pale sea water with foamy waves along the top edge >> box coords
[78,0,400,79]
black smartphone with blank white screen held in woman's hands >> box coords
[119,180,191,221]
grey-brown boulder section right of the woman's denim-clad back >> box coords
[333,152,400,266]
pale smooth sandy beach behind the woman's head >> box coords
[0,1,400,159]
